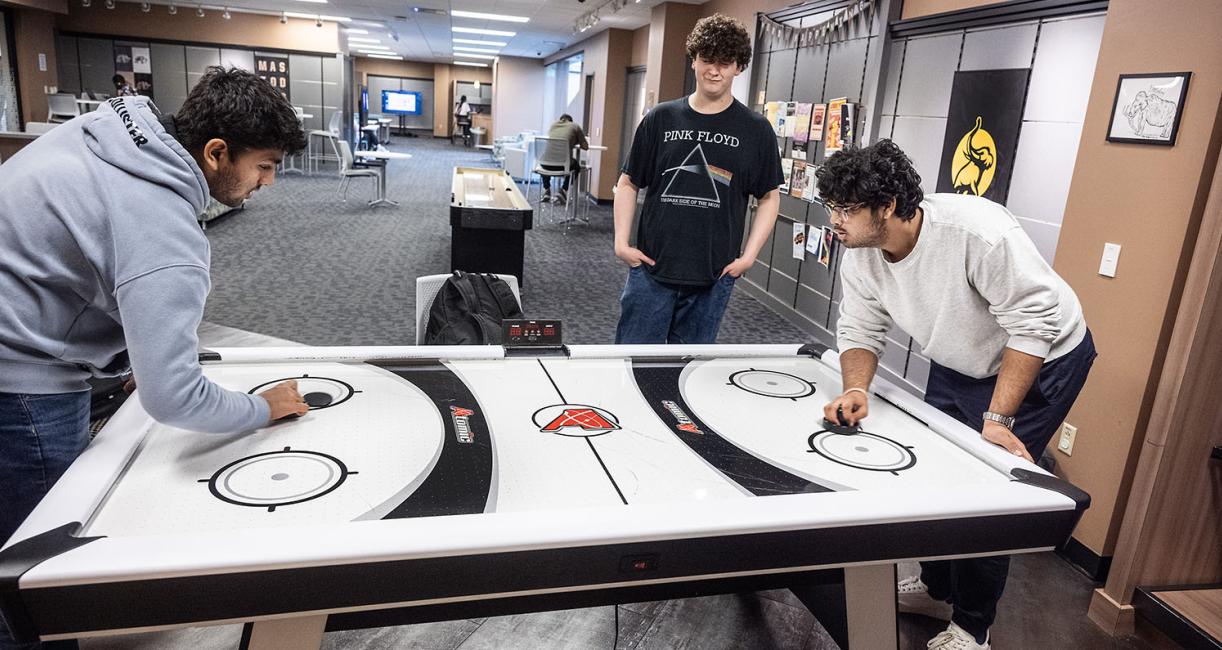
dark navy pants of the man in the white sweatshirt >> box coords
[920,330,1096,641]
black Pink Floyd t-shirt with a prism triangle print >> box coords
[622,97,785,286]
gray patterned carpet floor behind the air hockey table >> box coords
[205,138,808,346]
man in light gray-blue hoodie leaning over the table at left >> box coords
[0,67,308,649]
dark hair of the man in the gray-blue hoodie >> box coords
[174,66,306,158]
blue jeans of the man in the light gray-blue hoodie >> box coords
[0,391,89,650]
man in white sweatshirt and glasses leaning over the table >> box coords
[815,141,1095,650]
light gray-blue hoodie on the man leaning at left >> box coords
[0,97,269,431]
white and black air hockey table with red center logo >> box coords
[0,345,1089,649]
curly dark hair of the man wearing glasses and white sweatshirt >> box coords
[815,139,925,221]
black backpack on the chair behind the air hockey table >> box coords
[424,271,524,346]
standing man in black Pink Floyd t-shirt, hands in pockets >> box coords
[615,13,783,343]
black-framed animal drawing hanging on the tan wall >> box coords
[1107,72,1191,147]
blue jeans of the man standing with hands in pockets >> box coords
[615,266,737,343]
